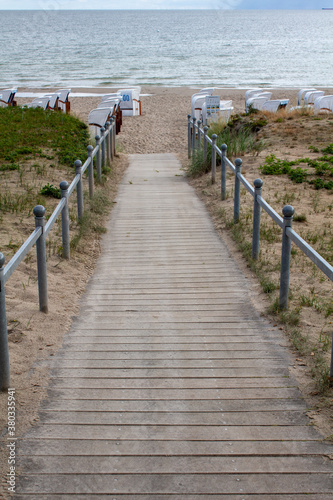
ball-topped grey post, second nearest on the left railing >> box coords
[33,205,48,313]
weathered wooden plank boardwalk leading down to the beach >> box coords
[16,155,333,500]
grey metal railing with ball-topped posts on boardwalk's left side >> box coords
[0,117,116,390]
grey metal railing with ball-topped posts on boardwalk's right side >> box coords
[188,115,333,380]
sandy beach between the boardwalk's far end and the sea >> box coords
[17,86,331,155]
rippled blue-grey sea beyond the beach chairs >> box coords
[0,10,333,88]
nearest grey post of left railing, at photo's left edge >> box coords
[0,253,10,391]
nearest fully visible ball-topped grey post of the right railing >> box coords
[279,205,295,309]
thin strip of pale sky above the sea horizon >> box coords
[0,0,326,10]
